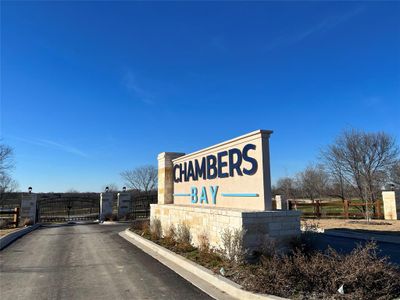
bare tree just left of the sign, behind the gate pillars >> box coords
[121,165,158,192]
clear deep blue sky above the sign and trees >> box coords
[0,1,400,191]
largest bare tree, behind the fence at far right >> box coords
[322,130,399,203]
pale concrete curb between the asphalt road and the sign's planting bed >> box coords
[119,229,285,300]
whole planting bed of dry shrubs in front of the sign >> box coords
[131,220,400,299]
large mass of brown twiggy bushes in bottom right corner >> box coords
[235,243,400,299]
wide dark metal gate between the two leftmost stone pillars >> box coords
[38,196,100,223]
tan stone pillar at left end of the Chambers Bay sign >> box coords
[157,152,185,204]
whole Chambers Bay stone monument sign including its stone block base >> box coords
[150,130,301,248]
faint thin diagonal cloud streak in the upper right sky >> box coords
[265,7,364,50]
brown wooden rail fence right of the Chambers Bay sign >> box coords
[289,200,383,219]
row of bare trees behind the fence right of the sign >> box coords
[273,129,400,203]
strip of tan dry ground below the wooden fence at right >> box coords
[302,219,400,234]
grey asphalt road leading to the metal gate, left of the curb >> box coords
[0,224,211,300]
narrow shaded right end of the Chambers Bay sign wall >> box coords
[261,130,272,210]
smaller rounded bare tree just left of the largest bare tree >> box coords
[296,165,329,201]
